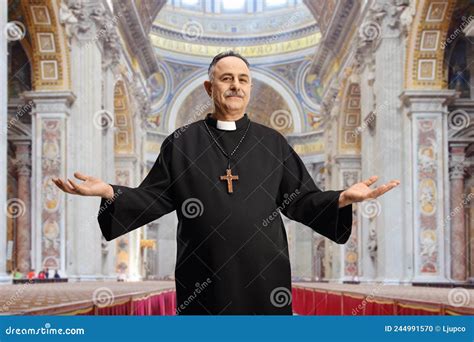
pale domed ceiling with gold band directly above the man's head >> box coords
[150,0,320,58]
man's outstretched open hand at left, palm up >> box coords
[52,172,114,199]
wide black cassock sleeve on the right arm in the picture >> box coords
[277,140,352,244]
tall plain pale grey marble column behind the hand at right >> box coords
[370,6,408,284]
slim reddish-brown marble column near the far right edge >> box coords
[445,143,468,282]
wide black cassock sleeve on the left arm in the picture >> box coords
[97,139,175,241]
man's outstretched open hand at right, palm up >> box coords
[339,176,400,208]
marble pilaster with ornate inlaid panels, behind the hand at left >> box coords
[23,91,75,276]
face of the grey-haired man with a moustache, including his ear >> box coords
[204,56,251,114]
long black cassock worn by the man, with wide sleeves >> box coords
[98,114,352,315]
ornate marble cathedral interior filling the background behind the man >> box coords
[0,0,474,314]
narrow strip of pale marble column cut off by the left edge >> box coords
[0,1,10,283]
